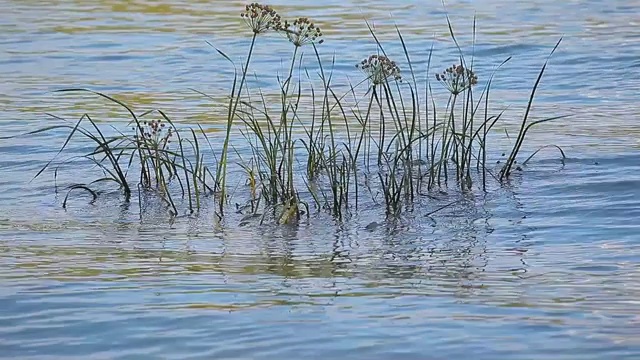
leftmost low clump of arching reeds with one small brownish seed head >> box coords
[15,89,213,215]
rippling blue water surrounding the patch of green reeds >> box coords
[0,0,640,359]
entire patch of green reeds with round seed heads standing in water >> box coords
[17,3,564,223]
